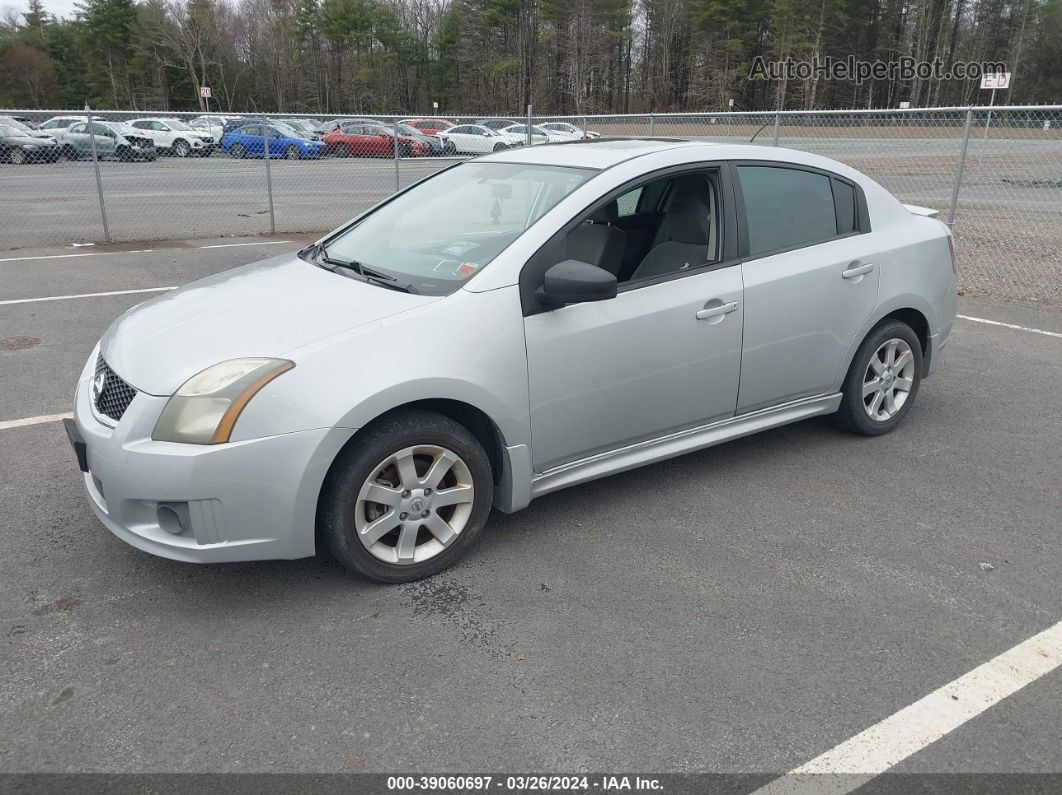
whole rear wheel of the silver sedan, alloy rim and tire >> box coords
[837,321,922,436]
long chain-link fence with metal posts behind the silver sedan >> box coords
[0,106,1062,304]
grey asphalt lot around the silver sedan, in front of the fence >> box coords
[0,237,1062,774]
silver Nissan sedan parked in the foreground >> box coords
[67,139,956,582]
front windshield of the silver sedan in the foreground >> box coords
[325,162,595,295]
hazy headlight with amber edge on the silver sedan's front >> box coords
[151,359,295,445]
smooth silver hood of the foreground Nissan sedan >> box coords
[101,254,439,395]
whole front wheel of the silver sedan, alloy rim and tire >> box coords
[318,411,494,583]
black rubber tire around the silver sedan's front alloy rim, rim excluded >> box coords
[318,410,494,583]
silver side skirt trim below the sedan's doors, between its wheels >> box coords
[531,393,841,499]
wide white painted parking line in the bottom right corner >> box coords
[755,621,1062,795]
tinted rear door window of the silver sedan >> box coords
[737,166,838,255]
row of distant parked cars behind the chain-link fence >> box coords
[0,114,598,163]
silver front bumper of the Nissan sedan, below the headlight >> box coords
[71,353,353,563]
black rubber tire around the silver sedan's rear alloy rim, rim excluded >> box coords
[834,319,922,436]
